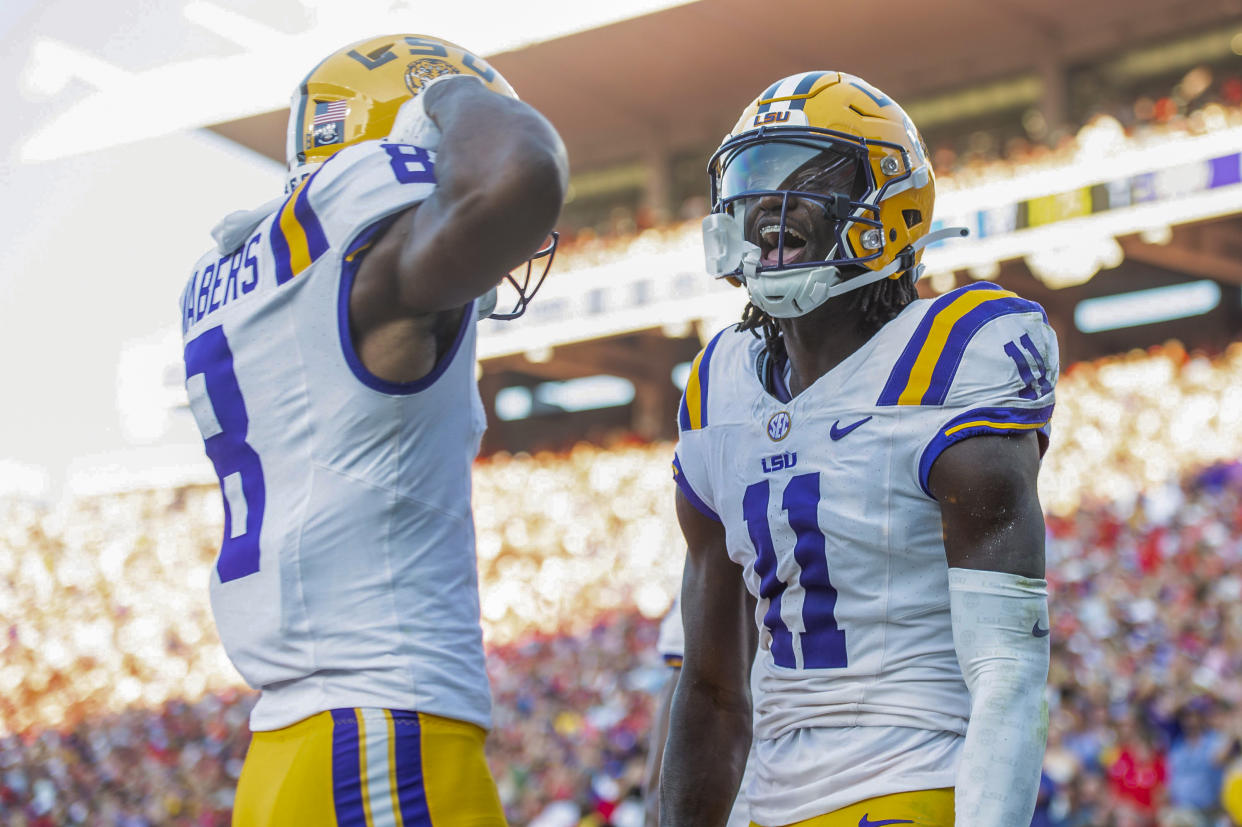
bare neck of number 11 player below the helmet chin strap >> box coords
[776,299,878,396]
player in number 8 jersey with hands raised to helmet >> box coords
[181,35,568,827]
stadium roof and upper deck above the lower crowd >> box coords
[211,0,1242,451]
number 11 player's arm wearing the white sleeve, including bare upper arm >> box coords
[928,432,1049,827]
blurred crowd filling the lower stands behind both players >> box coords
[0,344,1242,827]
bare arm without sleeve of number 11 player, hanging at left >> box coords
[660,490,756,827]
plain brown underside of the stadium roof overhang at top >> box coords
[211,0,1238,169]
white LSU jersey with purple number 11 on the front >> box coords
[673,283,1058,823]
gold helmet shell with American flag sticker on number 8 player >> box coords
[286,35,518,190]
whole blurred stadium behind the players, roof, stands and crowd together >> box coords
[0,0,1242,827]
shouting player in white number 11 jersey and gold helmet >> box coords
[661,72,1058,827]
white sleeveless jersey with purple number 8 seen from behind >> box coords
[181,142,491,730]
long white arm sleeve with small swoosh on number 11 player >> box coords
[949,569,1049,827]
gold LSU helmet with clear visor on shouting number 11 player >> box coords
[703,72,965,318]
